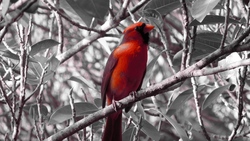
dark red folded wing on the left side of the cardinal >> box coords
[101,53,117,108]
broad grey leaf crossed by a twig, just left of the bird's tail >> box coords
[49,102,98,124]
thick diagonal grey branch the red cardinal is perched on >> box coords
[44,30,250,140]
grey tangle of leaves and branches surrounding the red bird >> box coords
[0,0,250,141]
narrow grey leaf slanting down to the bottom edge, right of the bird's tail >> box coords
[163,115,189,141]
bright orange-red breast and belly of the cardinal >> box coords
[110,46,147,100]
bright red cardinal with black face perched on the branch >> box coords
[101,22,154,141]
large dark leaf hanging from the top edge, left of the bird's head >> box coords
[60,0,109,26]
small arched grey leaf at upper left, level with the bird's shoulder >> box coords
[29,39,59,56]
